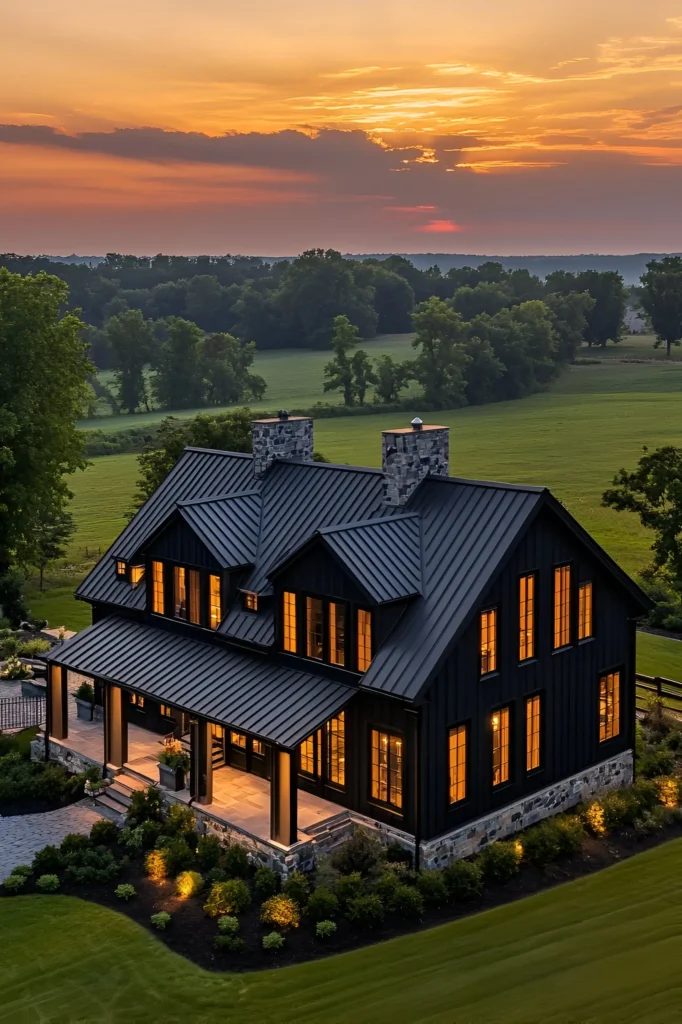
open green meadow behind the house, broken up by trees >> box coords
[30,336,682,679]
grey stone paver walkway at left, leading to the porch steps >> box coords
[0,798,102,882]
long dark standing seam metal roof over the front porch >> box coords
[48,615,356,750]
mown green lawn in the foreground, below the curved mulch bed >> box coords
[0,840,682,1024]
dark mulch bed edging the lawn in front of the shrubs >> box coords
[8,822,682,971]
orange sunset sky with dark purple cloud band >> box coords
[0,0,682,255]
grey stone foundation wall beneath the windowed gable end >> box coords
[420,751,634,867]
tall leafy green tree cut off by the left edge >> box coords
[0,269,94,575]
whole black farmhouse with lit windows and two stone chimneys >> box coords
[46,413,647,865]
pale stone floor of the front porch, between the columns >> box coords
[52,699,344,841]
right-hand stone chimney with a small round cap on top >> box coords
[381,416,450,505]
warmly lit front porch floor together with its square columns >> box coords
[46,664,345,848]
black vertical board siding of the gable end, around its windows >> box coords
[419,511,635,838]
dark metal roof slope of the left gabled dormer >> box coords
[178,490,260,568]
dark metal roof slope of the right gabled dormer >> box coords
[318,515,422,604]
